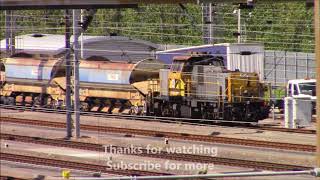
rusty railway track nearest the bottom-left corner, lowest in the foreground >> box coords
[0,152,171,176]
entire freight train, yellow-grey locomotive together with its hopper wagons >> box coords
[0,54,269,122]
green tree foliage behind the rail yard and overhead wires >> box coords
[0,2,314,52]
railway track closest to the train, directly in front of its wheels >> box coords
[0,107,316,134]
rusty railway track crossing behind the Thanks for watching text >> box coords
[0,133,312,171]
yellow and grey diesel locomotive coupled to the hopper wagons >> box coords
[148,54,269,122]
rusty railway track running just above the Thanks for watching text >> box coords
[1,117,316,152]
